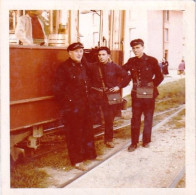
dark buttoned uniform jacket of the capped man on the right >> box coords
[123,54,163,97]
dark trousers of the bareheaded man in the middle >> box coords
[101,101,119,142]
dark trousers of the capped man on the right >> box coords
[131,98,155,144]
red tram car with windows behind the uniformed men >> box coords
[9,10,124,160]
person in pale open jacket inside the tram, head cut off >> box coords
[15,10,48,45]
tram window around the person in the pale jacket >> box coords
[9,10,70,46]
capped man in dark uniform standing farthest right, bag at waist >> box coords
[123,39,163,152]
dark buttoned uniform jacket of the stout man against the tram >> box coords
[53,58,89,111]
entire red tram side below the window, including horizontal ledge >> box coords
[10,47,68,132]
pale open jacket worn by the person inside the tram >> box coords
[15,14,48,45]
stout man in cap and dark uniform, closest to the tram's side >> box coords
[54,42,96,170]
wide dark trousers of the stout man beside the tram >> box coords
[63,106,96,165]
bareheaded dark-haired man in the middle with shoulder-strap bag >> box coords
[89,47,130,148]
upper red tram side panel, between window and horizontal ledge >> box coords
[10,47,68,101]
